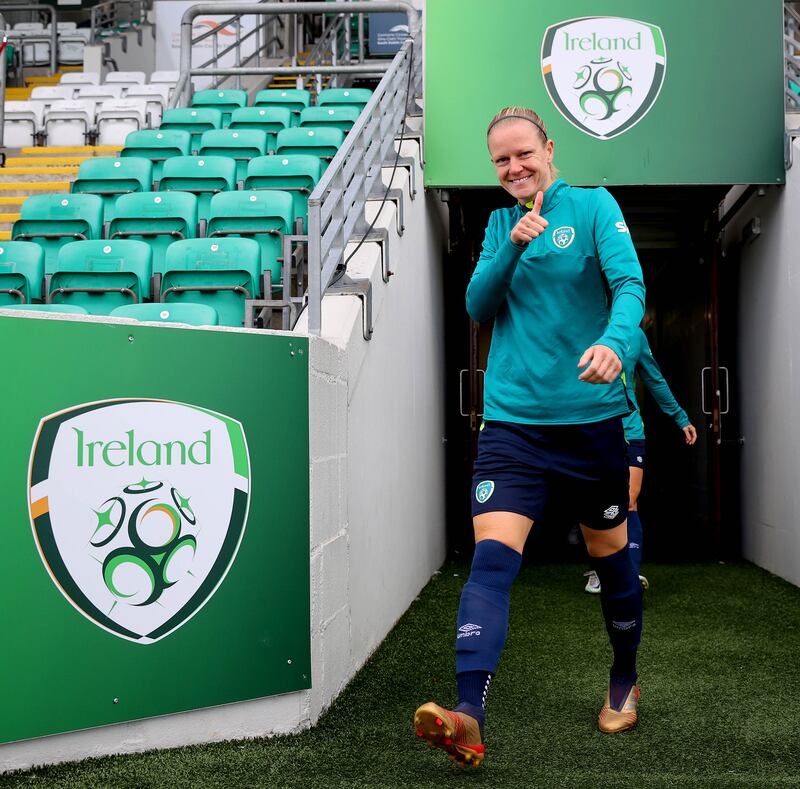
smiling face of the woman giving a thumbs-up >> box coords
[487,118,553,203]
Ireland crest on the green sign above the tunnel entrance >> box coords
[542,16,667,140]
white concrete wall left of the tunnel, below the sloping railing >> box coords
[0,142,445,772]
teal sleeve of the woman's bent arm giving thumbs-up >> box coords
[467,212,527,321]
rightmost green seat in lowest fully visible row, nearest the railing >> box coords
[161,238,261,326]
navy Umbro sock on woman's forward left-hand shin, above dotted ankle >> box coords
[456,540,522,676]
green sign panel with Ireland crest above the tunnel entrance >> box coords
[425,0,784,187]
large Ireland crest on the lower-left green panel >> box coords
[28,399,250,644]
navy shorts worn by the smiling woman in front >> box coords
[471,417,628,529]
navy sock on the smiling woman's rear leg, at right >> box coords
[591,544,642,707]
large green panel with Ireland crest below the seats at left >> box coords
[0,317,311,742]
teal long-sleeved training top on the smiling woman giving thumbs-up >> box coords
[467,179,644,425]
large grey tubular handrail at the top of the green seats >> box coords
[170,0,419,107]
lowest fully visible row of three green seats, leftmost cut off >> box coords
[0,238,260,326]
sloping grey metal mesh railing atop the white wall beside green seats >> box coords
[308,33,422,334]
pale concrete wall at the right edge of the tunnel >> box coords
[726,131,800,585]
